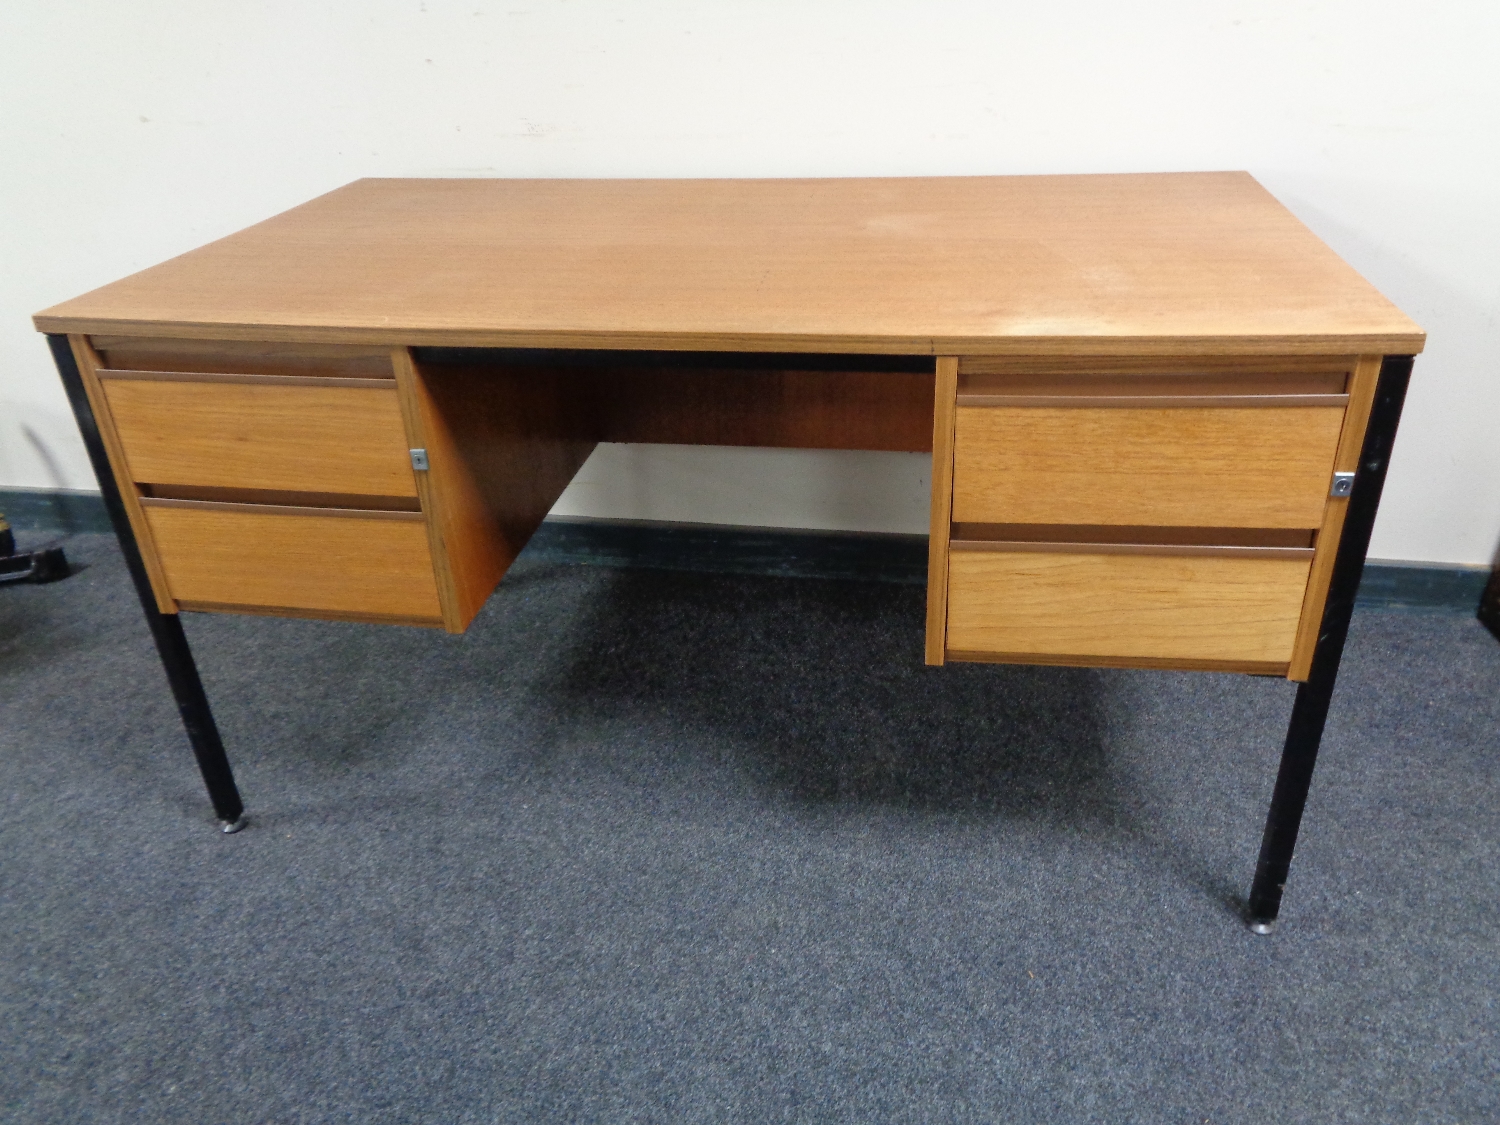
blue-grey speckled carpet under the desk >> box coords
[0,536,1500,1125]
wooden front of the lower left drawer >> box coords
[141,498,443,626]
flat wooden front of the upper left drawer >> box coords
[101,379,417,497]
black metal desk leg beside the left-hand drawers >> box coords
[47,336,245,833]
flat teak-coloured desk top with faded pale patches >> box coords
[35,173,1425,356]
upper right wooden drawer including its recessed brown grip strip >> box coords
[953,372,1347,528]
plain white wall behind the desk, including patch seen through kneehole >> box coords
[0,0,1500,563]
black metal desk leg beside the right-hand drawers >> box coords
[1247,356,1412,933]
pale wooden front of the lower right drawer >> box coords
[947,551,1311,672]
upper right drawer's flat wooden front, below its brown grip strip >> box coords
[953,404,1344,528]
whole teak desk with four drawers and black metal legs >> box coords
[36,173,1424,932]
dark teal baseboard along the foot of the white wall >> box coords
[0,489,1490,614]
